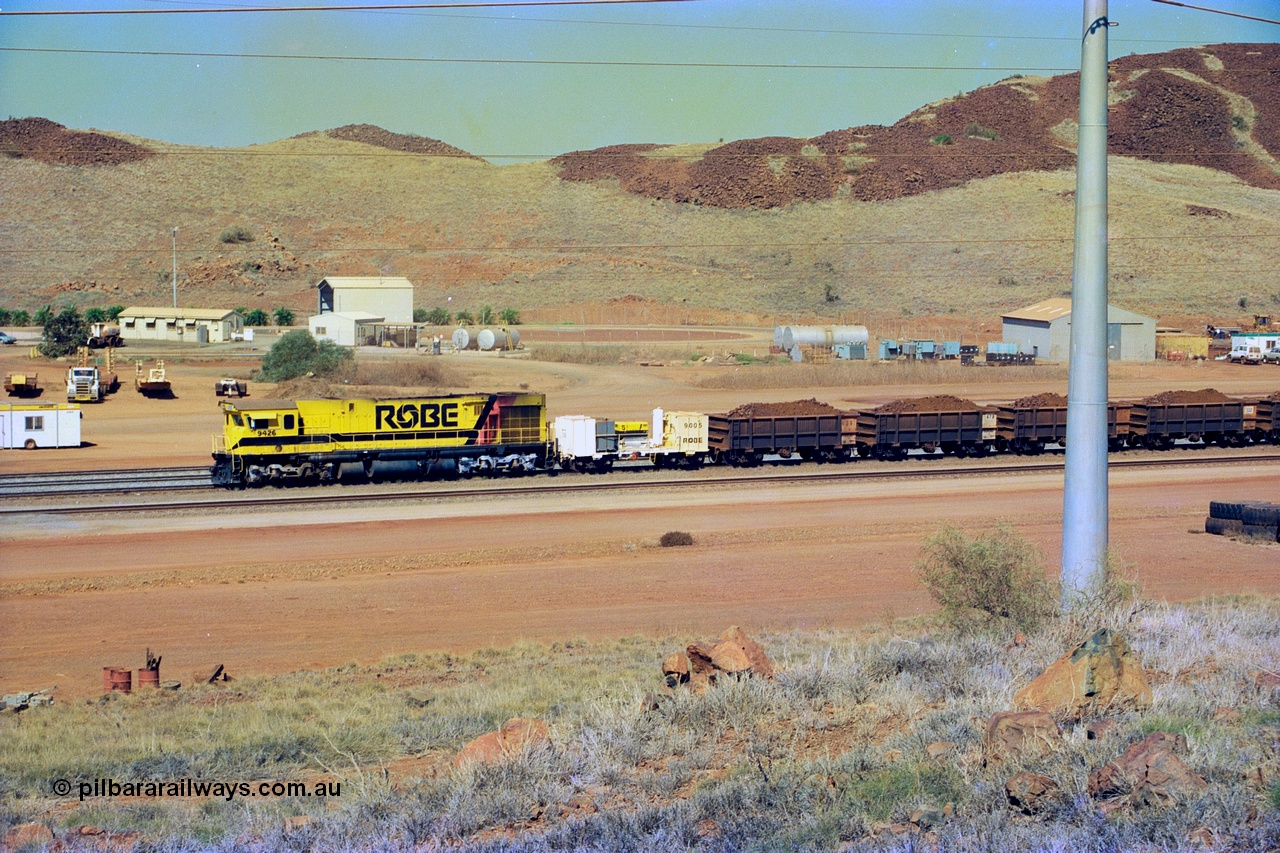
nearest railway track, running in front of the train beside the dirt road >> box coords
[0,453,1280,516]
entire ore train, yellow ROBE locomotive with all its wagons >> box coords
[204,388,1280,487]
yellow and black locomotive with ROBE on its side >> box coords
[210,392,548,487]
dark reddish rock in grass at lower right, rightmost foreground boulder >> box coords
[1087,731,1208,807]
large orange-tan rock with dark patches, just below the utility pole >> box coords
[1014,628,1151,719]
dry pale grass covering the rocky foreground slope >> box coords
[0,589,1280,852]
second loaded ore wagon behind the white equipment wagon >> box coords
[846,394,997,460]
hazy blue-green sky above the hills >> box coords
[0,0,1280,163]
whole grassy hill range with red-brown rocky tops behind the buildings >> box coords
[0,45,1280,323]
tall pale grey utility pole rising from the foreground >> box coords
[1061,0,1111,607]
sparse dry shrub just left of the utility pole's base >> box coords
[915,524,1057,628]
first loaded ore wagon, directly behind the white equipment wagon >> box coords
[707,400,850,466]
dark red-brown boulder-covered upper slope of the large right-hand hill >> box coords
[554,45,1280,209]
